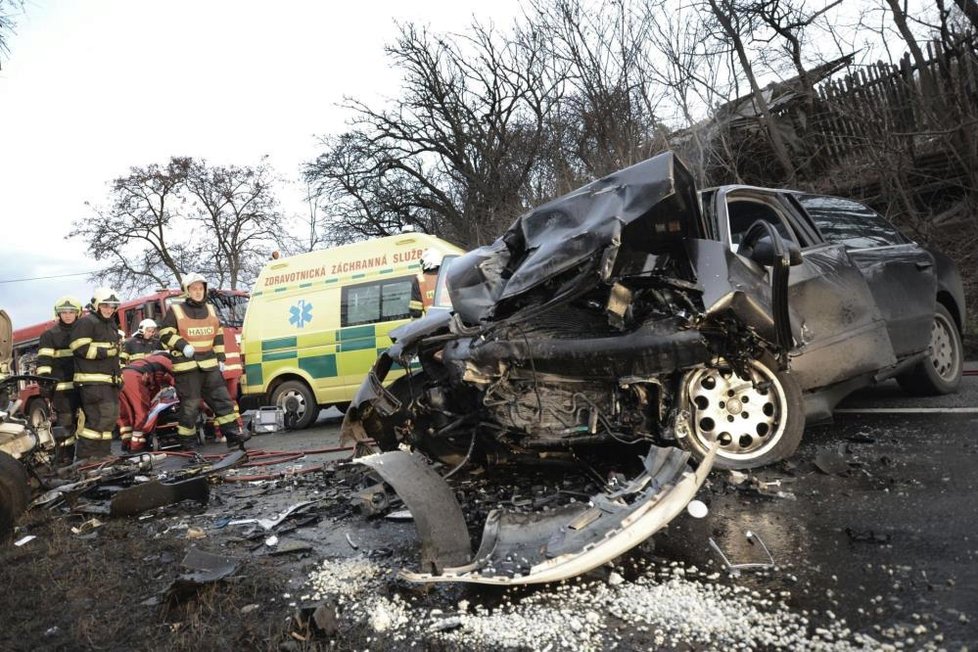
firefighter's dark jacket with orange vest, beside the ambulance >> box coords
[160,299,224,374]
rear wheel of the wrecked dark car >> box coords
[897,304,964,396]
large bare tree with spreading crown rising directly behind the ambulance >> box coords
[306,24,559,246]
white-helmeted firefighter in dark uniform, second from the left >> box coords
[71,287,119,460]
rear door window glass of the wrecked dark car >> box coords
[795,194,909,249]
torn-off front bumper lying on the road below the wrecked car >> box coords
[365,446,716,585]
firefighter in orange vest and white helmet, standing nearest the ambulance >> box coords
[160,273,251,450]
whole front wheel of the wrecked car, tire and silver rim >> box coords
[680,356,805,469]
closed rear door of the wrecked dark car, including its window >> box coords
[793,193,937,358]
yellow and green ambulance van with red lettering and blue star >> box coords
[241,233,464,428]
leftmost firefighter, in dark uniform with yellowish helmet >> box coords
[36,296,81,464]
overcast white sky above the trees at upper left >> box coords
[0,0,516,328]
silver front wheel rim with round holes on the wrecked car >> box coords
[686,362,787,460]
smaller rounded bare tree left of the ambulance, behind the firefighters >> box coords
[67,157,278,292]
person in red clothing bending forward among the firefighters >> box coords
[119,351,173,453]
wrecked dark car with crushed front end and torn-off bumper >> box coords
[343,153,964,584]
